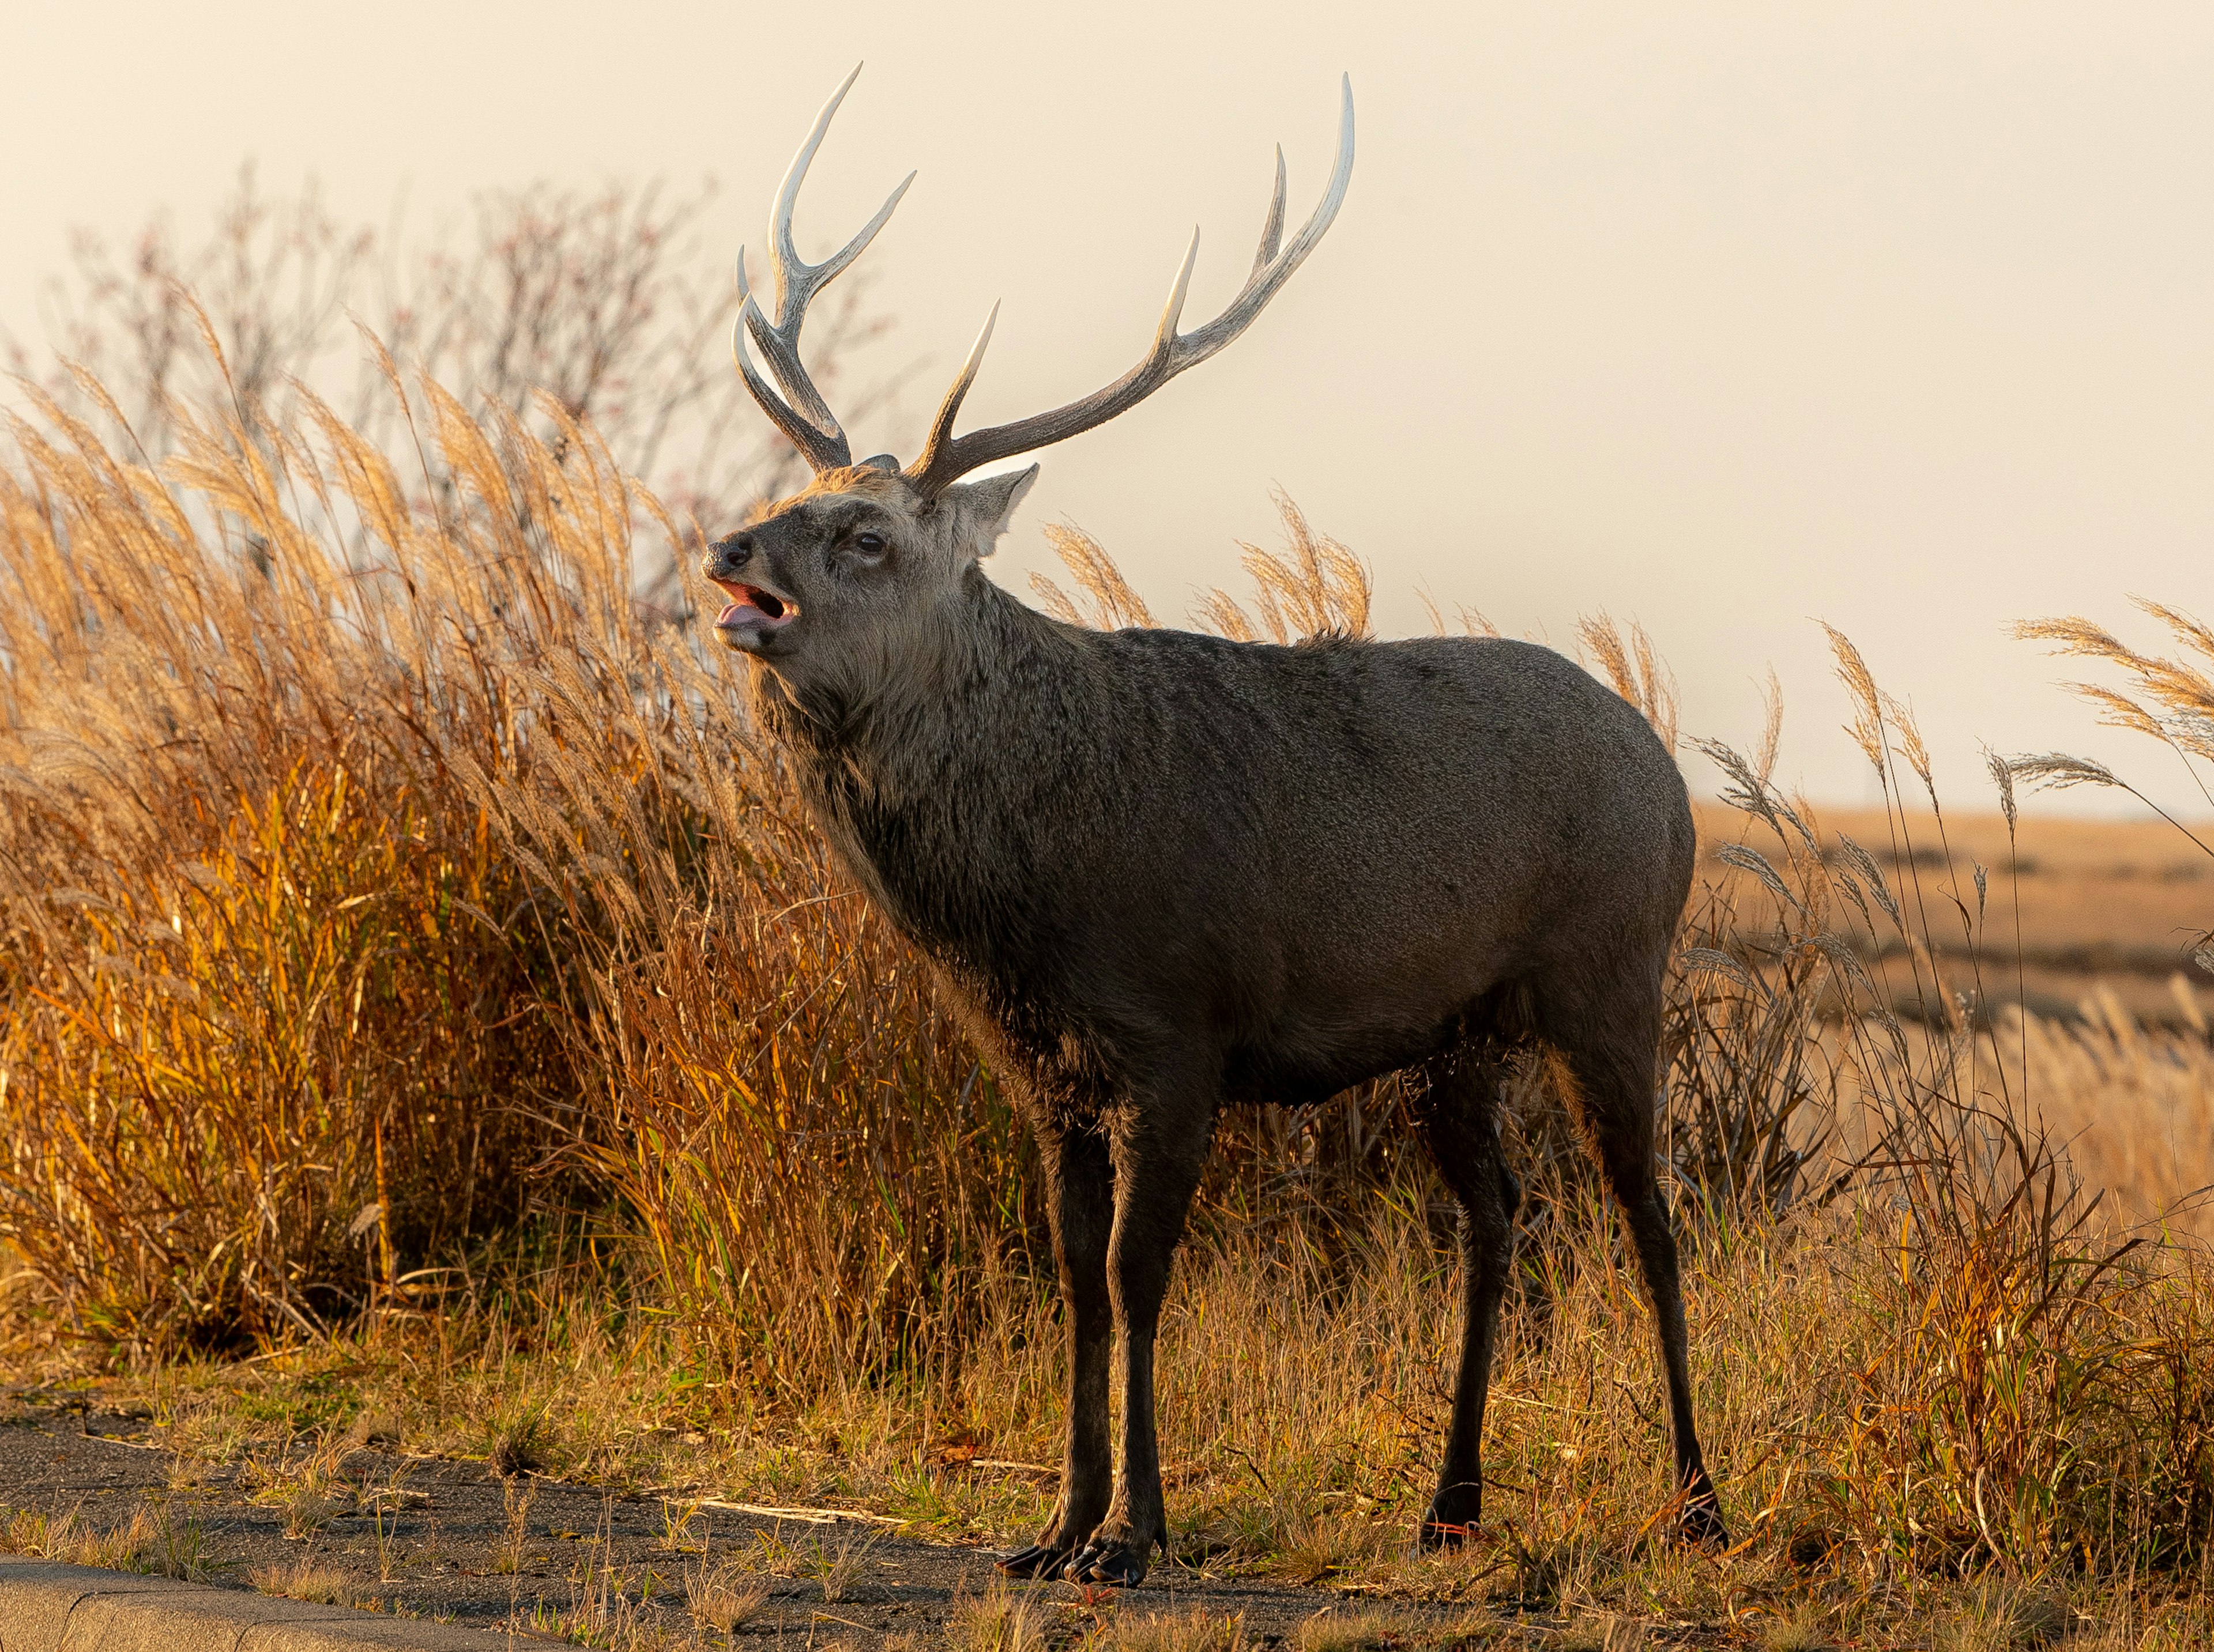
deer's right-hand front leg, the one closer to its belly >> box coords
[1067,1096,1213,1586]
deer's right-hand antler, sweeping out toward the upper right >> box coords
[906,76,1353,492]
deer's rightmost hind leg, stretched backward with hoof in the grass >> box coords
[1537,965,1729,1544]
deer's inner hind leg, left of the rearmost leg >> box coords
[1417,1041,1521,1548]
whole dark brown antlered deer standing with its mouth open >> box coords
[699,69,1727,1586]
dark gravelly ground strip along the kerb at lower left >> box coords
[0,1395,1543,1647]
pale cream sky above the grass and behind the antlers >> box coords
[0,0,2214,815]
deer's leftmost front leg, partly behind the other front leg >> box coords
[999,1121,1114,1576]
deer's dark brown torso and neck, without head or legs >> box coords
[762,569,1692,1114]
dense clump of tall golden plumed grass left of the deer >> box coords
[0,325,1023,1360]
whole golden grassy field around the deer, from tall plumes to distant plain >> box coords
[0,341,2214,1652]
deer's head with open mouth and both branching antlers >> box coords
[702,69,1353,689]
